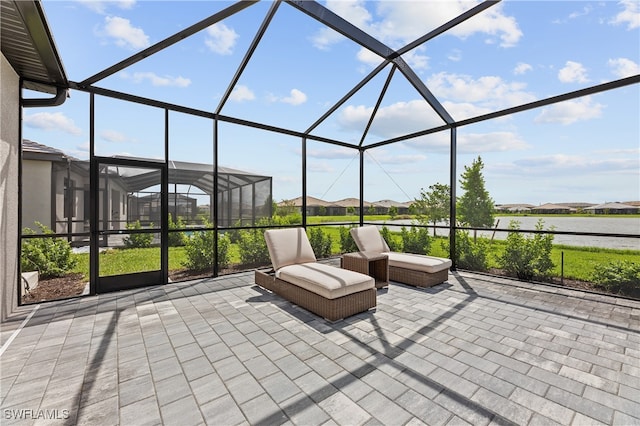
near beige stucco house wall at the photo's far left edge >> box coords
[0,55,20,321]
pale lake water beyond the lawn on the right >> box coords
[378,216,640,250]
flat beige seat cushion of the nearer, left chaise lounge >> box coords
[276,263,375,299]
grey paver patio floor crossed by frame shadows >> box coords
[0,273,640,425]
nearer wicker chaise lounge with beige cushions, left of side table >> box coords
[255,228,376,321]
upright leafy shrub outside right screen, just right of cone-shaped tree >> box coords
[498,219,554,280]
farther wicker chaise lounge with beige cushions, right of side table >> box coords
[350,225,452,287]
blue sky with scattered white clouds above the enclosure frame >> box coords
[23,0,640,204]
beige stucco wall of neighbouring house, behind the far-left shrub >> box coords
[22,160,53,232]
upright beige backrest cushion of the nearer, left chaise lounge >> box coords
[264,228,316,271]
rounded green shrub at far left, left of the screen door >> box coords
[20,222,77,278]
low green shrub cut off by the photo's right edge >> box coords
[591,261,640,297]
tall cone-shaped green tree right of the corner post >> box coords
[457,156,494,228]
